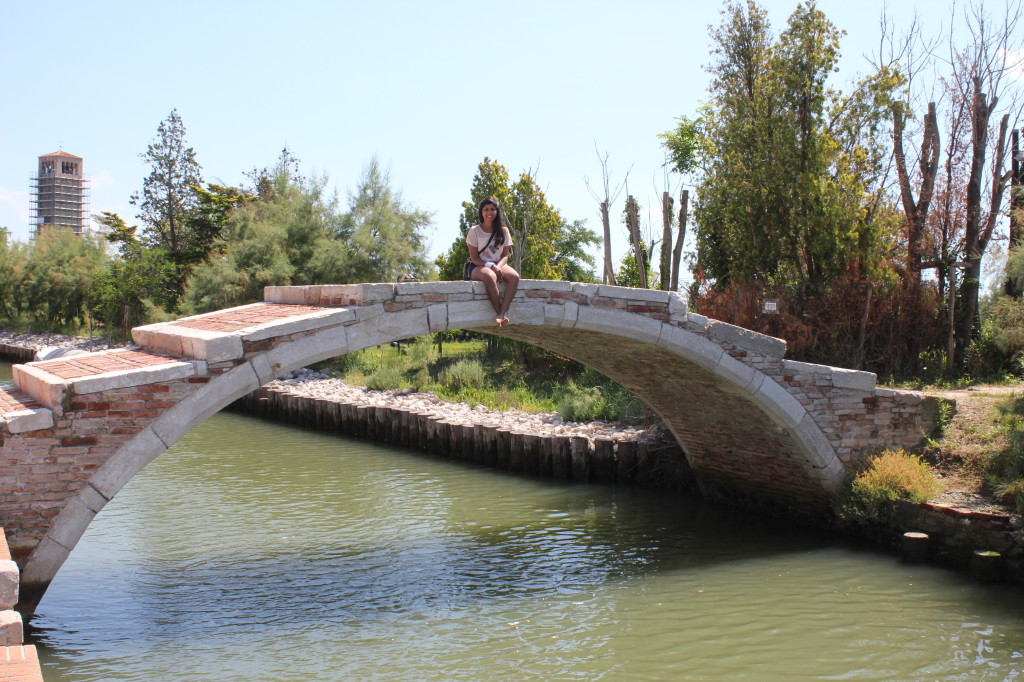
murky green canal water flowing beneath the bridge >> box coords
[0,358,1024,682]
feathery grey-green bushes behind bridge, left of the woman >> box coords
[184,155,433,312]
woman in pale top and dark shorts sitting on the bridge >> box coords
[466,197,519,327]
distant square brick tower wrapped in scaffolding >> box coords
[30,152,89,236]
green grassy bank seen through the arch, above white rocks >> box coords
[319,333,654,423]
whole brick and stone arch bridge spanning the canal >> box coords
[0,281,935,613]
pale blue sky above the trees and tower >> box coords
[0,0,1004,274]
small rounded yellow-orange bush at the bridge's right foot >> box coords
[850,450,941,518]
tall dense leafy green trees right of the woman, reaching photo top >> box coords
[694,0,900,288]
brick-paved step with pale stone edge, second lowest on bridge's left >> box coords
[12,347,200,415]
